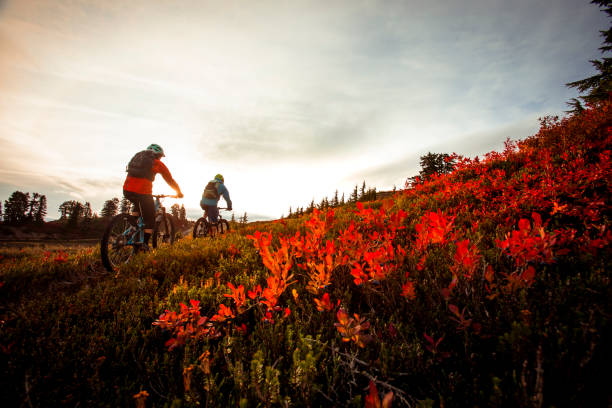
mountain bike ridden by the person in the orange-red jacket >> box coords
[100,194,178,272]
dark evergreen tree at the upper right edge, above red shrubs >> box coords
[565,0,612,113]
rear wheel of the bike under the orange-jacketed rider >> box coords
[100,214,139,272]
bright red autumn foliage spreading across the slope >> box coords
[154,103,612,352]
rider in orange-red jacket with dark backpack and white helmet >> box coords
[123,143,183,248]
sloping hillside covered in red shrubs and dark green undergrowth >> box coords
[0,103,612,407]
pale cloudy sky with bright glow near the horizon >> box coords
[0,0,609,220]
